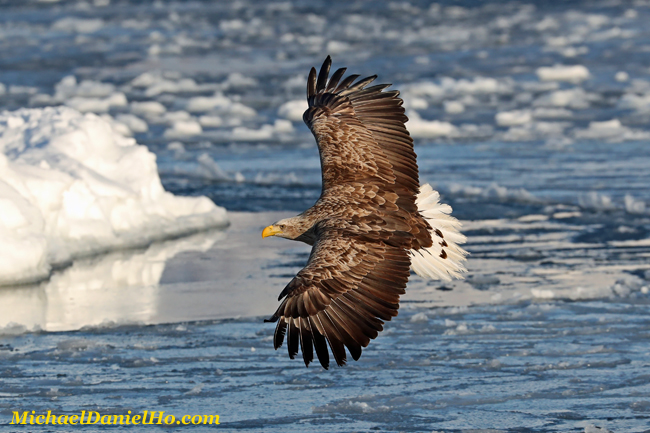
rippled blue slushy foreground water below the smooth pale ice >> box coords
[0,298,650,433]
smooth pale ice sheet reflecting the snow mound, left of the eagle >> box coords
[0,212,290,330]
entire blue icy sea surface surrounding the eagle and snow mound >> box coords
[0,0,650,433]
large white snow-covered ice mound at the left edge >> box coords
[0,107,228,284]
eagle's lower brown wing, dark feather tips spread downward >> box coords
[268,228,410,369]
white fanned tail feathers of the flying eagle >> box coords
[409,184,468,281]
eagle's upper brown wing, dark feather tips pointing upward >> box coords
[303,56,420,219]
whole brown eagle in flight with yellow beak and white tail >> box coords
[262,56,467,369]
